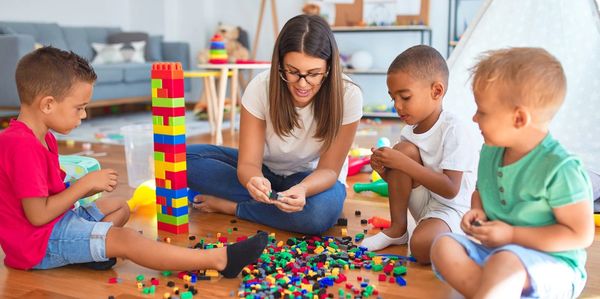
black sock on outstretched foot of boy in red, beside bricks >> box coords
[220,232,269,278]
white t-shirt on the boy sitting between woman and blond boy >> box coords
[400,111,483,212]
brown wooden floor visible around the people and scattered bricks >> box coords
[0,123,600,298]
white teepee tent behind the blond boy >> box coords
[444,0,600,170]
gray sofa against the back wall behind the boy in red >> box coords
[0,22,190,109]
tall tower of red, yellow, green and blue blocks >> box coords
[152,62,189,234]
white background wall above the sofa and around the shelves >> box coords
[0,0,480,103]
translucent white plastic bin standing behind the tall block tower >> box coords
[121,124,154,188]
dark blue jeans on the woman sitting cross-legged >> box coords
[187,144,346,235]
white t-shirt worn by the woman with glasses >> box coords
[242,71,362,183]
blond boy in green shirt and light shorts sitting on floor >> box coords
[431,48,594,298]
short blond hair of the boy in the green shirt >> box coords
[471,48,567,121]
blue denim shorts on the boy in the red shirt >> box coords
[33,203,112,269]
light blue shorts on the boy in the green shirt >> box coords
[432,233,585,298]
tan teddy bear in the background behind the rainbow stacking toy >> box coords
[197,23,250,63]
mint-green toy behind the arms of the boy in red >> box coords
[58,155,102,206]
